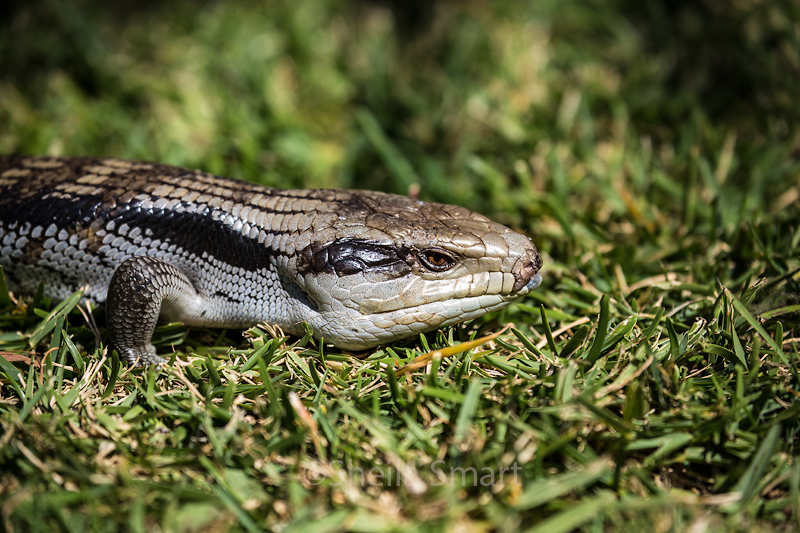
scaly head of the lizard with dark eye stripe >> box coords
[282,191,542,350]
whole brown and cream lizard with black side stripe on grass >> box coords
[0,156,541,364]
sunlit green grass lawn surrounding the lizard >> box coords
[0,0,800,533]
